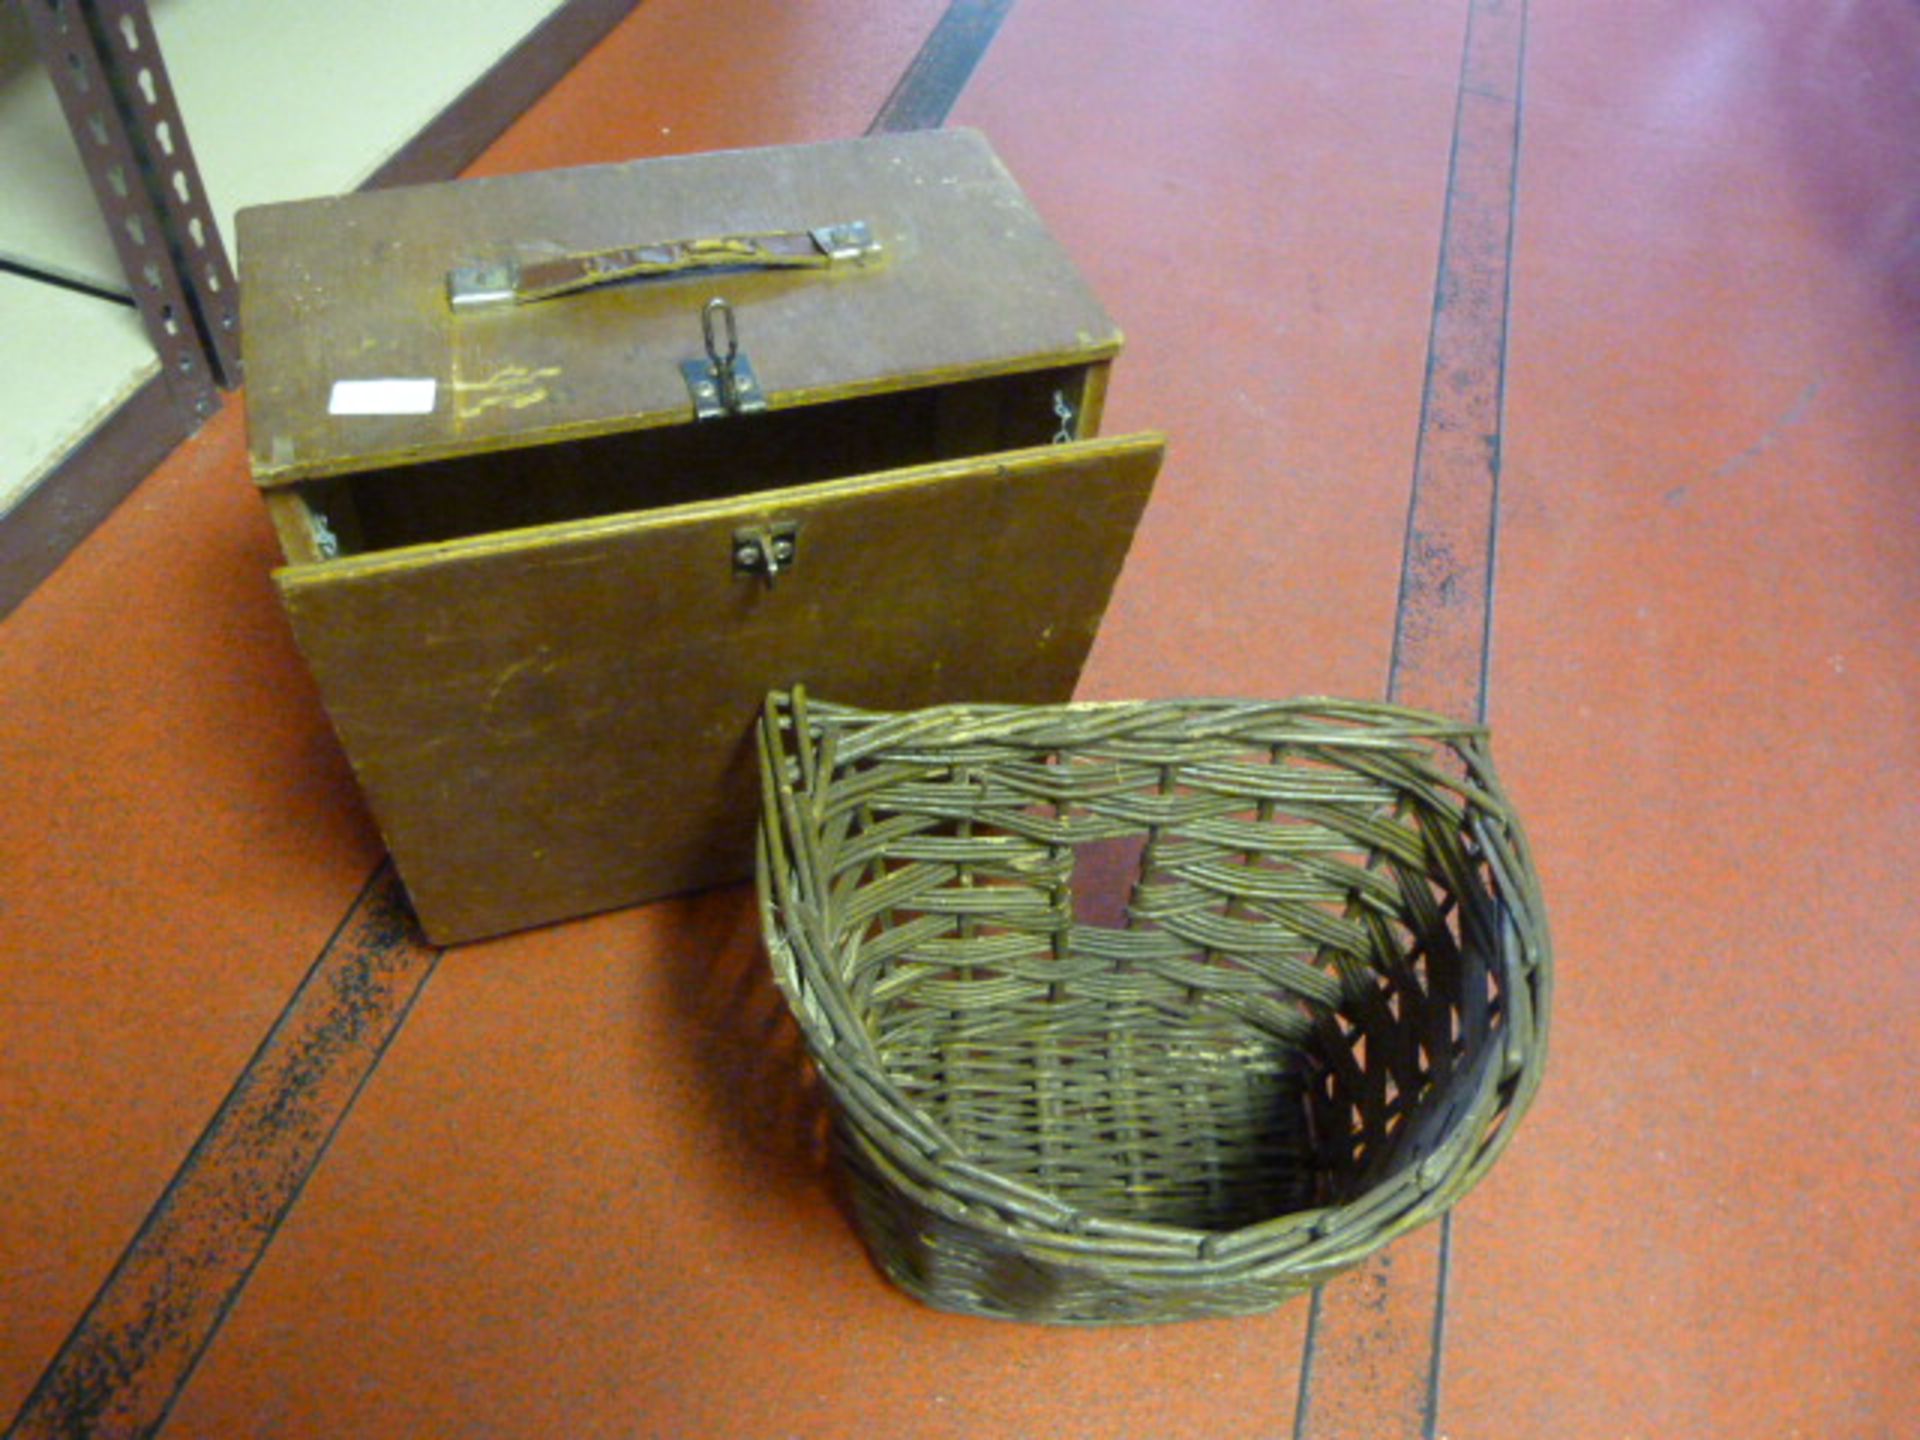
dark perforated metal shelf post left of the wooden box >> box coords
[21,0,240,420]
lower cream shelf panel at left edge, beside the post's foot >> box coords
[0,275,159,515]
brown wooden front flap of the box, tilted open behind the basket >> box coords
[278,436,1164,943]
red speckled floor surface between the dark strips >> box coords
[0,0,1920,1440]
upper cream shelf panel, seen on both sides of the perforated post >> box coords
[0,0,561,293]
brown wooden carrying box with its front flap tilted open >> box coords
[238,131,1162,943]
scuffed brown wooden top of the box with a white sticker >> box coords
[238,131,1119,486]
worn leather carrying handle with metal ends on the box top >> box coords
[447,221,879,309]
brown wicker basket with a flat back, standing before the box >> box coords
[760,691,1551,1323]
